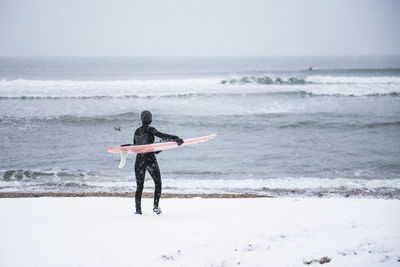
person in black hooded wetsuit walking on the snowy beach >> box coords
[133,110,183,214]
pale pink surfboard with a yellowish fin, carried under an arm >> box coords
[107,134,217,168]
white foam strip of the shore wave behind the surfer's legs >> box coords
[87,177,400,196]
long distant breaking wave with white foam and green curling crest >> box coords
[0,76,400,100]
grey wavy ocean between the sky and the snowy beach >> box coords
[0,57,400,198]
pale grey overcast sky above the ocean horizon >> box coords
[0,0,400,56]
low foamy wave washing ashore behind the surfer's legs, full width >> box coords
[0,170,400,198]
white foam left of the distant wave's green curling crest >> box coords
[0,79,219,97]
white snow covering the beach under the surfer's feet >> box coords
[0,198,400,267]
